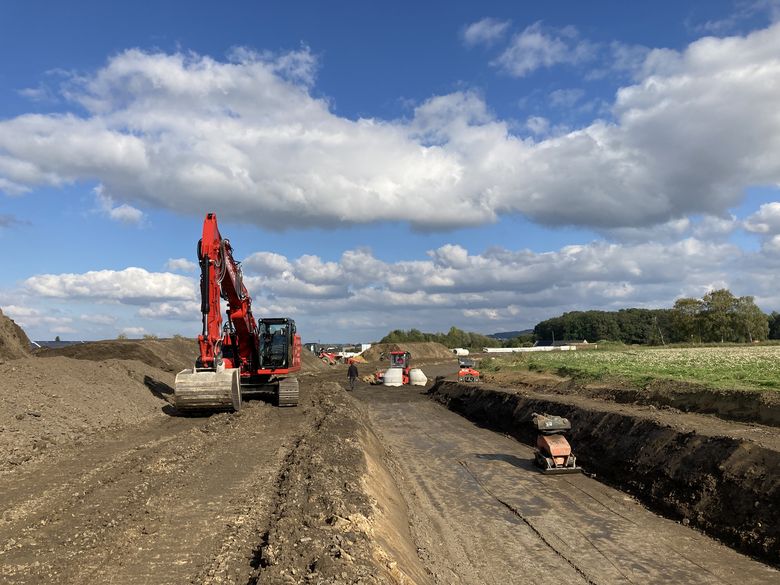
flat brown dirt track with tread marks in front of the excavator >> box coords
[0,396,311,583]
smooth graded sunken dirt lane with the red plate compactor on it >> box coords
[355,376,780,585]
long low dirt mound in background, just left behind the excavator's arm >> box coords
[36,337,198,373]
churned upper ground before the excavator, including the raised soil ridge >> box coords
[0,374,414,584]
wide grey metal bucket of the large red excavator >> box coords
[173,368,241,411]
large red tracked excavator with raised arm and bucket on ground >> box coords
[174,213,301,411]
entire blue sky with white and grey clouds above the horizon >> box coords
[0,0,780,341]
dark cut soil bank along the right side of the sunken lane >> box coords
[429,380,780,566]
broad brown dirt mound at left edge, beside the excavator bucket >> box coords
[0,356,173,473]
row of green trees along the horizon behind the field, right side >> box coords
[380,289,780,349]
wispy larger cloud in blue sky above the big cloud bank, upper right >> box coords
[493,22,596,77]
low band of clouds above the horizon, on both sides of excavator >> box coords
[9,225,780,341]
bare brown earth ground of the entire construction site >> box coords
[0,342,780,585]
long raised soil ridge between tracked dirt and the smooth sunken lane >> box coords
[251,382,429,585]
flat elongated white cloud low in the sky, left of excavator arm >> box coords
[24,267,195,305]
